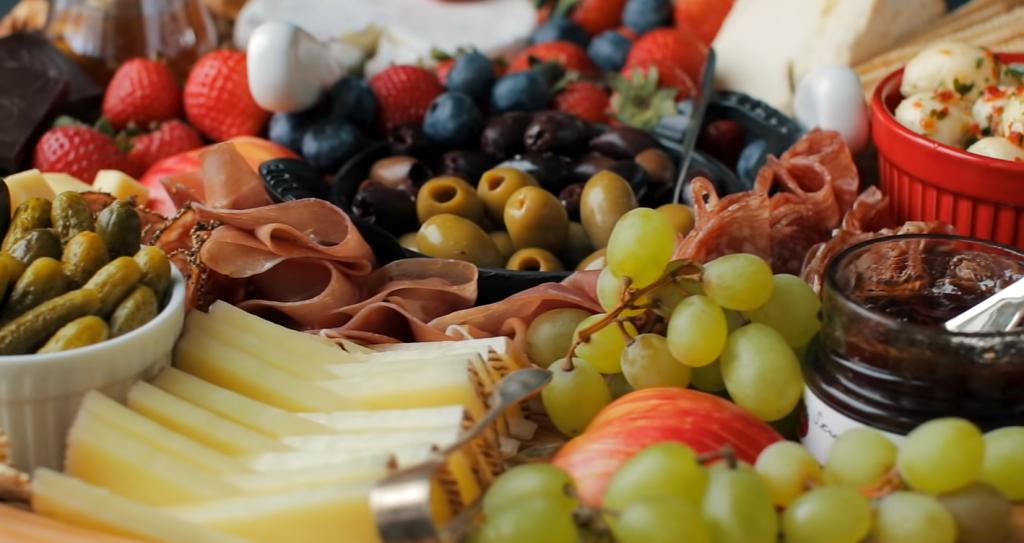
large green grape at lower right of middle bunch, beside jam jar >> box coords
[721,323,804,422]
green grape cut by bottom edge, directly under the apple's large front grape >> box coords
[612,496,712,543]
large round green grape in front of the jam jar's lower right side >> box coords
[896,418,985,494]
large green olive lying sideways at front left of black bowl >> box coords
[416,213,504,267]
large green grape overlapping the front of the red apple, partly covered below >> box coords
[602,442,708,512]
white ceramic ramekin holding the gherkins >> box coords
[0,266,185,471]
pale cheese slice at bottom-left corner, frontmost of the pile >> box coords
[32,469,253,543]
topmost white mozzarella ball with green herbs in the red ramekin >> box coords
[900,43,1000,101]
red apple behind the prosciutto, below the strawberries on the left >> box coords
[139,136,300,217]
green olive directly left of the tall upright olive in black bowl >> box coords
[505,186,569,254]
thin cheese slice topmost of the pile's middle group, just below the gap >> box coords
[153,368,331,437]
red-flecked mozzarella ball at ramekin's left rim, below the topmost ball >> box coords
[896,90,971,148]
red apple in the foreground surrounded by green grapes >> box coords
[552,387,783,506]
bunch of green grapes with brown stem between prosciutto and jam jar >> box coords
[526,208,821,435]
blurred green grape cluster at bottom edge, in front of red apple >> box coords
[472,443,778,543]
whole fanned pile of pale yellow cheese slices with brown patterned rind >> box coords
[33,302,536,543]
